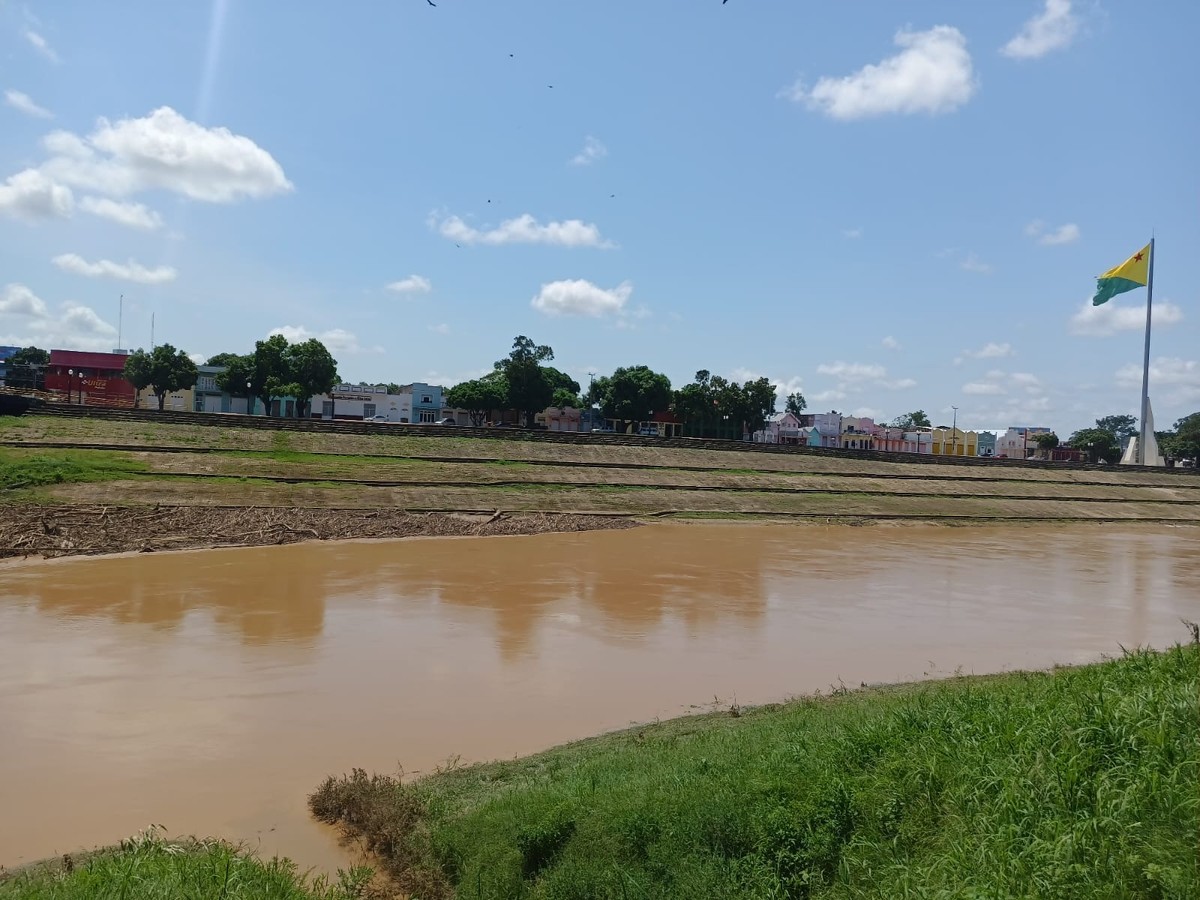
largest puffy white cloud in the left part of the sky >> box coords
[41,107,293,203]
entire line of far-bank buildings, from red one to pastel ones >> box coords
[0,347,1060,460]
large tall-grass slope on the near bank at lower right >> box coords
[310,644,1200,900]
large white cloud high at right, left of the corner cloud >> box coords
[785,25,976,121]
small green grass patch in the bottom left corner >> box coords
[0,829,372,900]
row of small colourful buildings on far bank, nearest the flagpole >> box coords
[751,413,1065,460]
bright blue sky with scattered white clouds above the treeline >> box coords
[0,0,1200,433]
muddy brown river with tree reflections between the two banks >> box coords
[0,524,1200,870]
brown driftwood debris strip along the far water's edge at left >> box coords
[0,504,636,558]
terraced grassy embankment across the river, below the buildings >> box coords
[0,409,1200,554]
